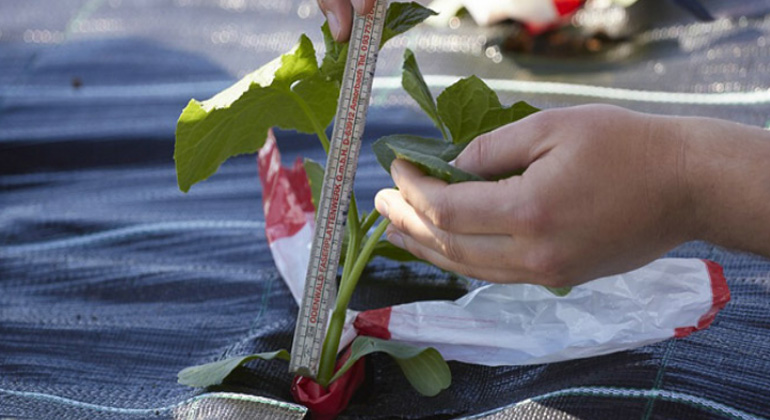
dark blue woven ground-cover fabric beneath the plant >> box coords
[0,0,770,420]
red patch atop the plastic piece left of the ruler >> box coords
[257,130,315,243]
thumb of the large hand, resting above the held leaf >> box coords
[454,112,548,179]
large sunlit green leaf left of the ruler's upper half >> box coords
[174,35,339,191]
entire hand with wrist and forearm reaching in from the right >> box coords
[375,105,770,287]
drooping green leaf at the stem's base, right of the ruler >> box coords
[329,337,452,397]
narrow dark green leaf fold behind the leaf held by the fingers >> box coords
[372,134,467,172]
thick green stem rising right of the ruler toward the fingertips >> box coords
[318,219,390,387]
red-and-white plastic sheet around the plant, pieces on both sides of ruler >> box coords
[259,134,730,366]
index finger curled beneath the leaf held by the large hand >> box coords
[391,159,520,234]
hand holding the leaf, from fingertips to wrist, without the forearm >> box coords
[375,105,695,287]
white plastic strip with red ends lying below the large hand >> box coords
[356,258,730,366]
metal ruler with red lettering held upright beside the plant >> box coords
[289,0,387,378]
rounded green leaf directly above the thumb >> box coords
[437,76,538,143]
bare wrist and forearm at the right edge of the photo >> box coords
[676,118,770,254]
